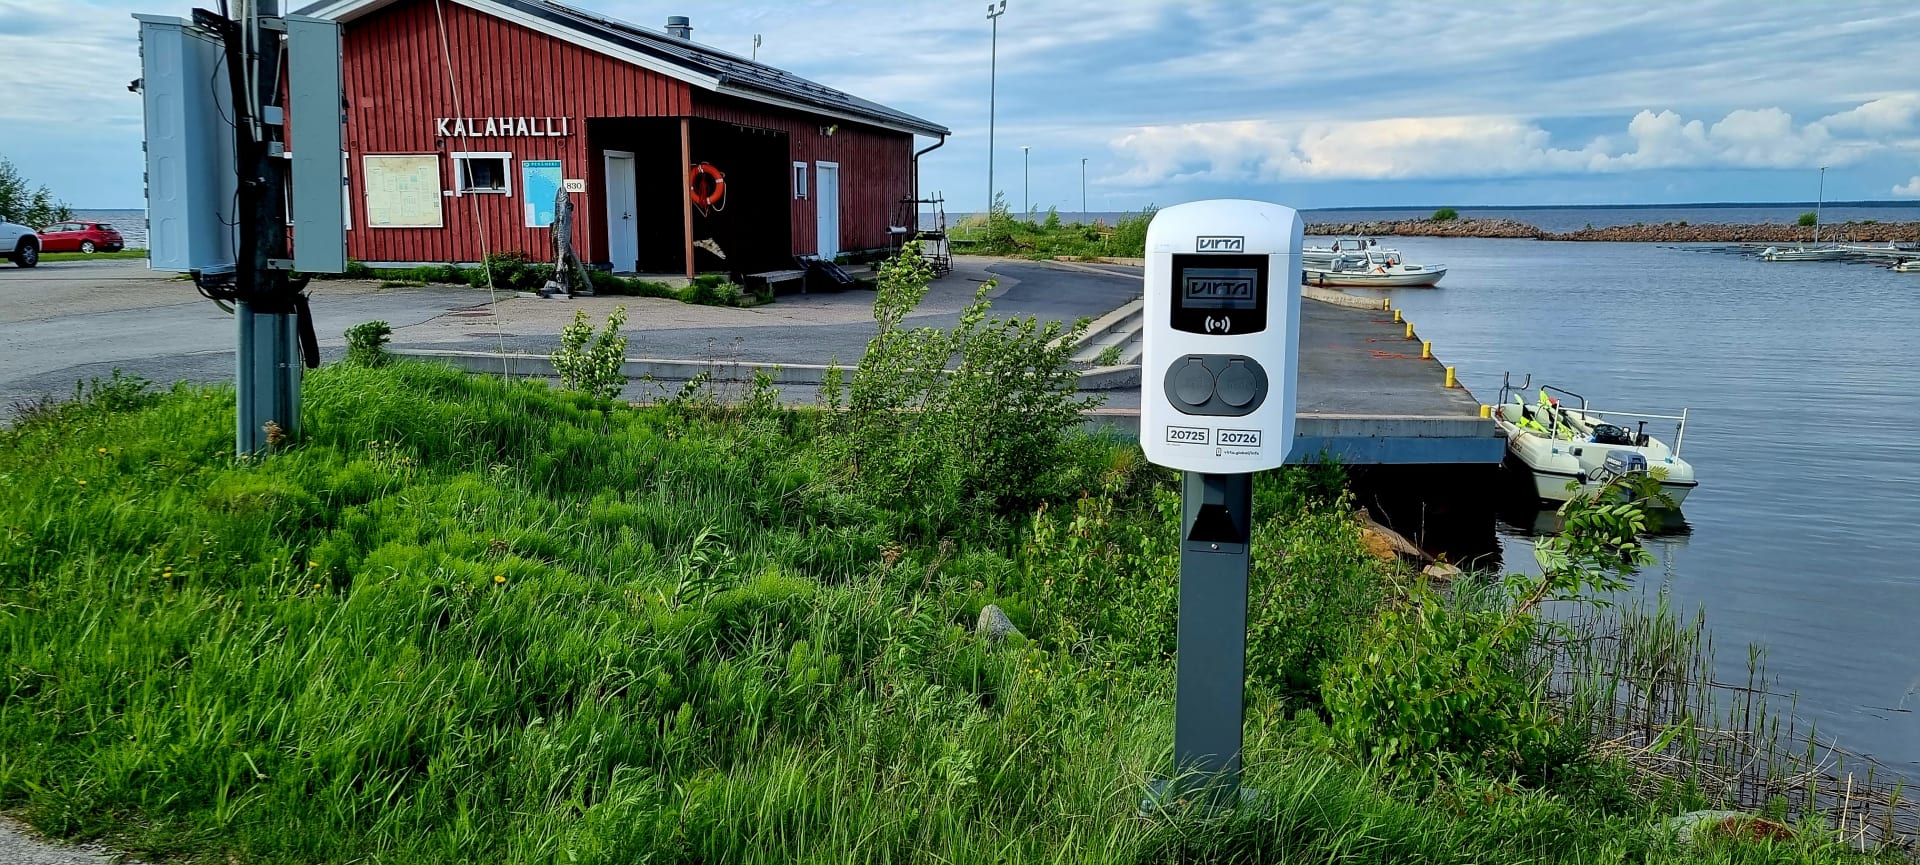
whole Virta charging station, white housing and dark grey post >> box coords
[1140,199,1304,807]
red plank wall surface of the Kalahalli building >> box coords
[342,0,914,261]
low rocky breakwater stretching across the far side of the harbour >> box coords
[1308,219,1920,244]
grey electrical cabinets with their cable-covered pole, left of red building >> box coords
[134,0,326,456]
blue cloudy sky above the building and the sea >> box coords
[0,0,1920,211]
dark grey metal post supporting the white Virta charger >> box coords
[1140,472,1254,811]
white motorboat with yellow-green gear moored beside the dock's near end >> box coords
[1494,376,1699,508]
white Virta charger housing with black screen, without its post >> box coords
[1140,199,1306,474]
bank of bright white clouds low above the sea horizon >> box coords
[1110,94,1920,186]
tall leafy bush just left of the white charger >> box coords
[837,244,1100,533]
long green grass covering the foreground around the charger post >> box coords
[0,364,1889,863]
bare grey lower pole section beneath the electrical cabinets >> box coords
[234,301,303,456]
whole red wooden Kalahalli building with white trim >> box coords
[292,0,948,274]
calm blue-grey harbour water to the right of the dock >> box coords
[1356,238,1920,779]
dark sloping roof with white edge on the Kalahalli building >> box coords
[303,0,950,136]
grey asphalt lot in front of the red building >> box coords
[0,259,1140,418]
